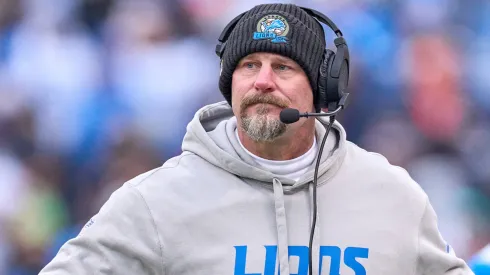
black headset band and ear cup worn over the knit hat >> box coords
[215,7,350,113]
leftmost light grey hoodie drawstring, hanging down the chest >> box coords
[273,178,289,275]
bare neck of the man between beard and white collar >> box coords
[238,122,315,160]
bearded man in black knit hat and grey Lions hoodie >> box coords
[41,4,472,275]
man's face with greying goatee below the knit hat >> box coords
[232,53,314,142]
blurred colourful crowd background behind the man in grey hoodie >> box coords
[0,0,490,275]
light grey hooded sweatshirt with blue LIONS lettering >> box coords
[41,102,473,275]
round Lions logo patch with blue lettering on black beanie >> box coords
[254,14,289,43]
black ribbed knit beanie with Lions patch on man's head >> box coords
[219,4,326,108]
